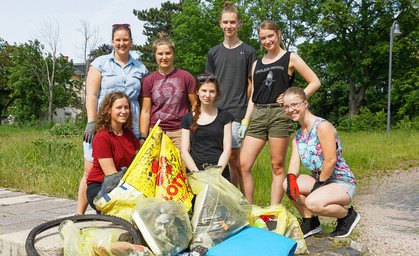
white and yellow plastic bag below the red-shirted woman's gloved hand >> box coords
[93,183,144,221]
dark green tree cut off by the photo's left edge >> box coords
[0,38,14,123]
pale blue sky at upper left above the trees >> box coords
[0,0,179,62]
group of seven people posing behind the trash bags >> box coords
[77,2,360,240]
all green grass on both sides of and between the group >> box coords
[0,126,419,208]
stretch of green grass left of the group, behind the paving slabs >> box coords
[0,126,83,199]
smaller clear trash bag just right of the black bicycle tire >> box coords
[131,197,192,255]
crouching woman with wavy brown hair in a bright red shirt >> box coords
[86,92,140,209]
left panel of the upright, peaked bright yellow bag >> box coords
[122,125,163,197]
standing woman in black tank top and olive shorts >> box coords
[239,20,320,204]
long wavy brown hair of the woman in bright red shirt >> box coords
[95,92,132,133]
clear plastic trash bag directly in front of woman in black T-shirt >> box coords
[188,167,251,250]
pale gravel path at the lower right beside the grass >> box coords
[354,166,419,255]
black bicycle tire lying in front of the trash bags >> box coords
[25,214,144,256]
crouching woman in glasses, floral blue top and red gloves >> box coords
[283,87,360,237]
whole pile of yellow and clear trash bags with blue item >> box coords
[60,125,308,256]
